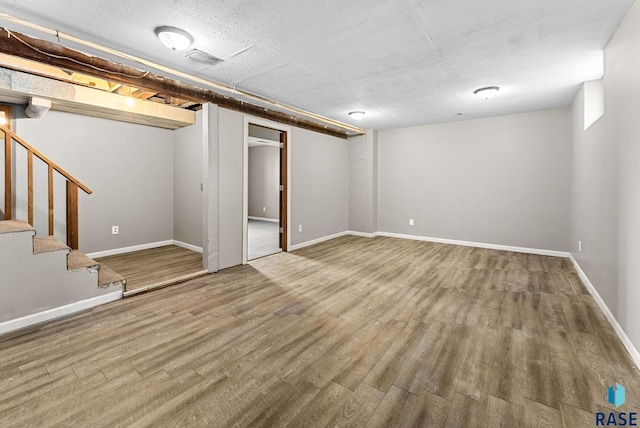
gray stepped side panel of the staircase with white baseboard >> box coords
[0,226,122,334]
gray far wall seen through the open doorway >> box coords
[248,146,280,220]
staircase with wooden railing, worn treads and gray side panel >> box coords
[0,125,126,334]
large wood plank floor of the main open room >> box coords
[0,237,640,427]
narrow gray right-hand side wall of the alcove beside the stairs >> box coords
[173,110,204,247]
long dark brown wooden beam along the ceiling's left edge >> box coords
[0,28,349,139]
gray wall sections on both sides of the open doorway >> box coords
[218,108,349,258]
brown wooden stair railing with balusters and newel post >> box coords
[0,125,93,250]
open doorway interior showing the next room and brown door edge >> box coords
[243,120,288,263]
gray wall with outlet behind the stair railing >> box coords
[15,111,173,253]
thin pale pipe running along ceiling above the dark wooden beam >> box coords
[0,13,365,135]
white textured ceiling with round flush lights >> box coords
[0,0,632,129]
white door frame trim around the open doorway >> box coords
[242,115,292,265]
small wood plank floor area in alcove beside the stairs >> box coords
[96,245,203,291]
